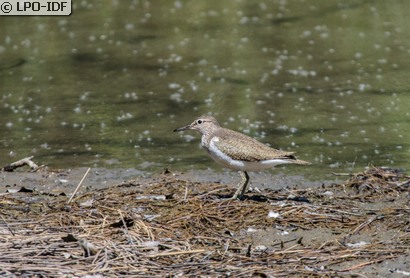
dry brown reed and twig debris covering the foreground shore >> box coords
[0,168,410,277]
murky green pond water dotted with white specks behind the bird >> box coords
[0,0,410,180]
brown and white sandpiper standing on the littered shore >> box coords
[174,115,311,200]
